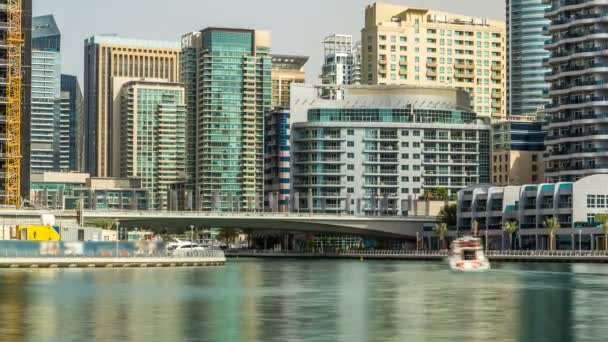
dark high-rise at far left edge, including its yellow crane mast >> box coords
[0,0,32,206]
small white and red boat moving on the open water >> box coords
[449,236,490,272]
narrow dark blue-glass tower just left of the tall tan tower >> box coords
[59,75,84,171]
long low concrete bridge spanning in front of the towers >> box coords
[0,210,436,238]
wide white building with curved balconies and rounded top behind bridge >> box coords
[290,85,491,215]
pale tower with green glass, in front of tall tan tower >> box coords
[115,81,186,210]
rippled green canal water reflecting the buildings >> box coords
[0,259,608,342]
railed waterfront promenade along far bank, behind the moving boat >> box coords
[226,250,608,263]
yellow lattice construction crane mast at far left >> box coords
[4,0,23,208]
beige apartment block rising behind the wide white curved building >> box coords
[361,2,506,118]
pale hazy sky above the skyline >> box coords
[33,0,505,86]
